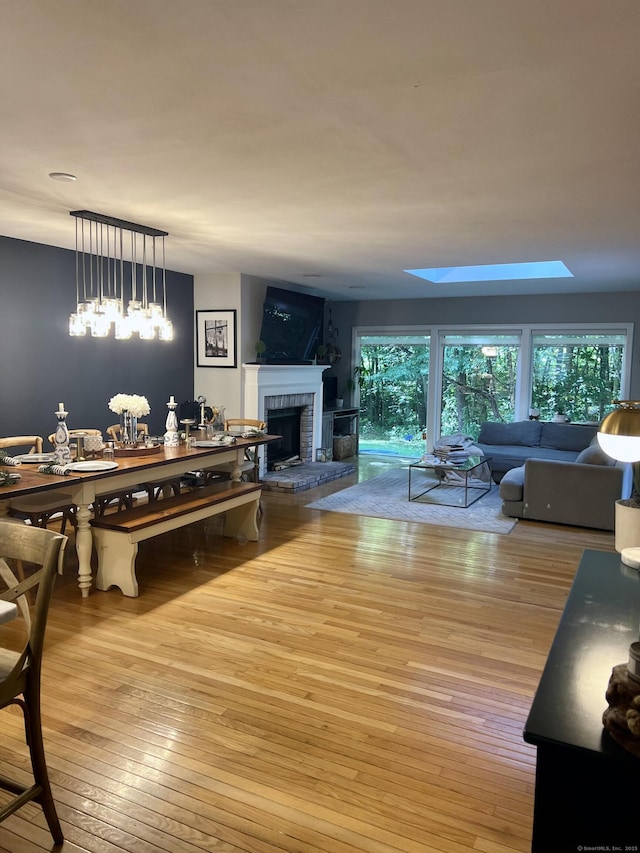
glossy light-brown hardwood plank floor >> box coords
[0,460,613,853]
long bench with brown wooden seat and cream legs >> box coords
[90,480,261,597]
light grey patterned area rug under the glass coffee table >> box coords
[306,468,516,534]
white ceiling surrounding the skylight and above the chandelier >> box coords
[0,0,640,299]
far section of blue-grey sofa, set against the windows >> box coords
[476,421,598,483]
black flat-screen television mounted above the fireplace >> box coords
[260,286,324,364]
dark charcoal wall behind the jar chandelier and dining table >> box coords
[0,237,194,446]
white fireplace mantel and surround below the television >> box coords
[242,364,328,459]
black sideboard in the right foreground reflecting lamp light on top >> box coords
[524,550,640,853]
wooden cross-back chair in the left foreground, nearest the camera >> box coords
[0,519,67,845]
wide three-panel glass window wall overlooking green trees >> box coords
[353,323,633,455]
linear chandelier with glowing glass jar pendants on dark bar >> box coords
[69,210,173,341]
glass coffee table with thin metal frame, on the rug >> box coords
[409,456,493,509]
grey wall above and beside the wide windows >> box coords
[331,286,640,392]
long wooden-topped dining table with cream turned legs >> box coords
[0,434,280,598]
